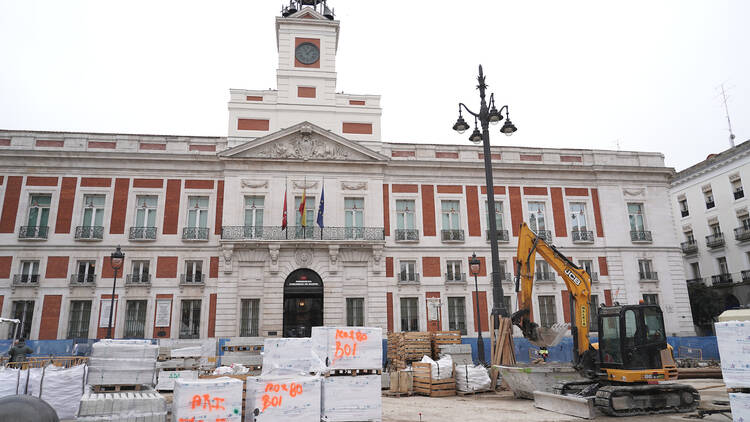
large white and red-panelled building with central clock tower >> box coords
[0,2,694,339]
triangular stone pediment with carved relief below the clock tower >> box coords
[219,121,388,162]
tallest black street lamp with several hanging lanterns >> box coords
[453,65,517,340]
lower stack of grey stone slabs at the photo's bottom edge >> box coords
[76,390,167,422]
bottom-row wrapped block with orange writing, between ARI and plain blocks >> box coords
[245,375,320,422]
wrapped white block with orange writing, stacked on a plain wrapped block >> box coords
[312,327,383,369]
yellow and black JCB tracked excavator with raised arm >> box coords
[511,223,700,416]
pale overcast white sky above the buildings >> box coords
[0,0,750,170]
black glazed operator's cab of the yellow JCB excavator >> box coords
[598,304,667,370]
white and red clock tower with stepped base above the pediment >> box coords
[228,0,381,150]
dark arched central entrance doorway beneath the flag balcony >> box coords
[283,268,323,337]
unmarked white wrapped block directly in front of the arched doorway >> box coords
[262,337,323,375]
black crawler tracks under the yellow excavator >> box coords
[594,384,700,416]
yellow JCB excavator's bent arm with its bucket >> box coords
[511,223,591,361]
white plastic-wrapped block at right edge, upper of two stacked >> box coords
[715,321,750,388]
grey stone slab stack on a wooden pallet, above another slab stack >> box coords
[87,340,159,386]
